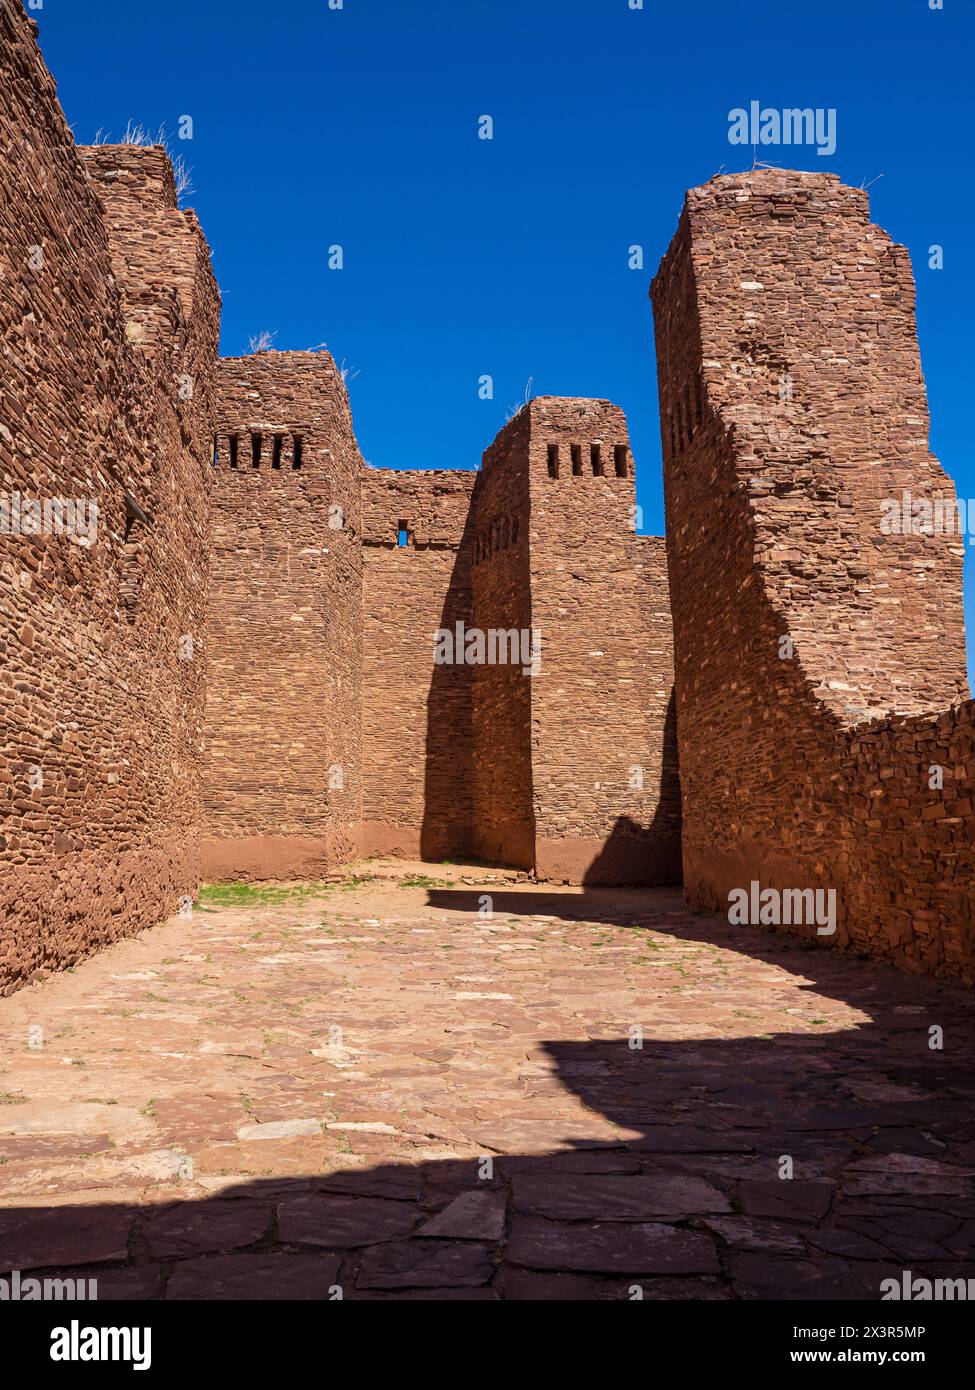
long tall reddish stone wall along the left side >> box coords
[0,0,218,991]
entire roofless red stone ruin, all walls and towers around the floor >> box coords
[0,0,975,992]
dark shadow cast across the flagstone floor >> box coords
[0,892,975,1301]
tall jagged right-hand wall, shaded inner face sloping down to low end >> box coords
[652,171,974,974]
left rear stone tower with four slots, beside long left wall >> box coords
[203,352,363,877]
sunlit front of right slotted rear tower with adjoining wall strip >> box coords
[527,398,680,883]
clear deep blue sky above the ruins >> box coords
[33,0,975,683]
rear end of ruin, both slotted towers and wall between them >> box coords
[204,378,680,883]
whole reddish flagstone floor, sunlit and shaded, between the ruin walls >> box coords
[0,863,975,1300]
